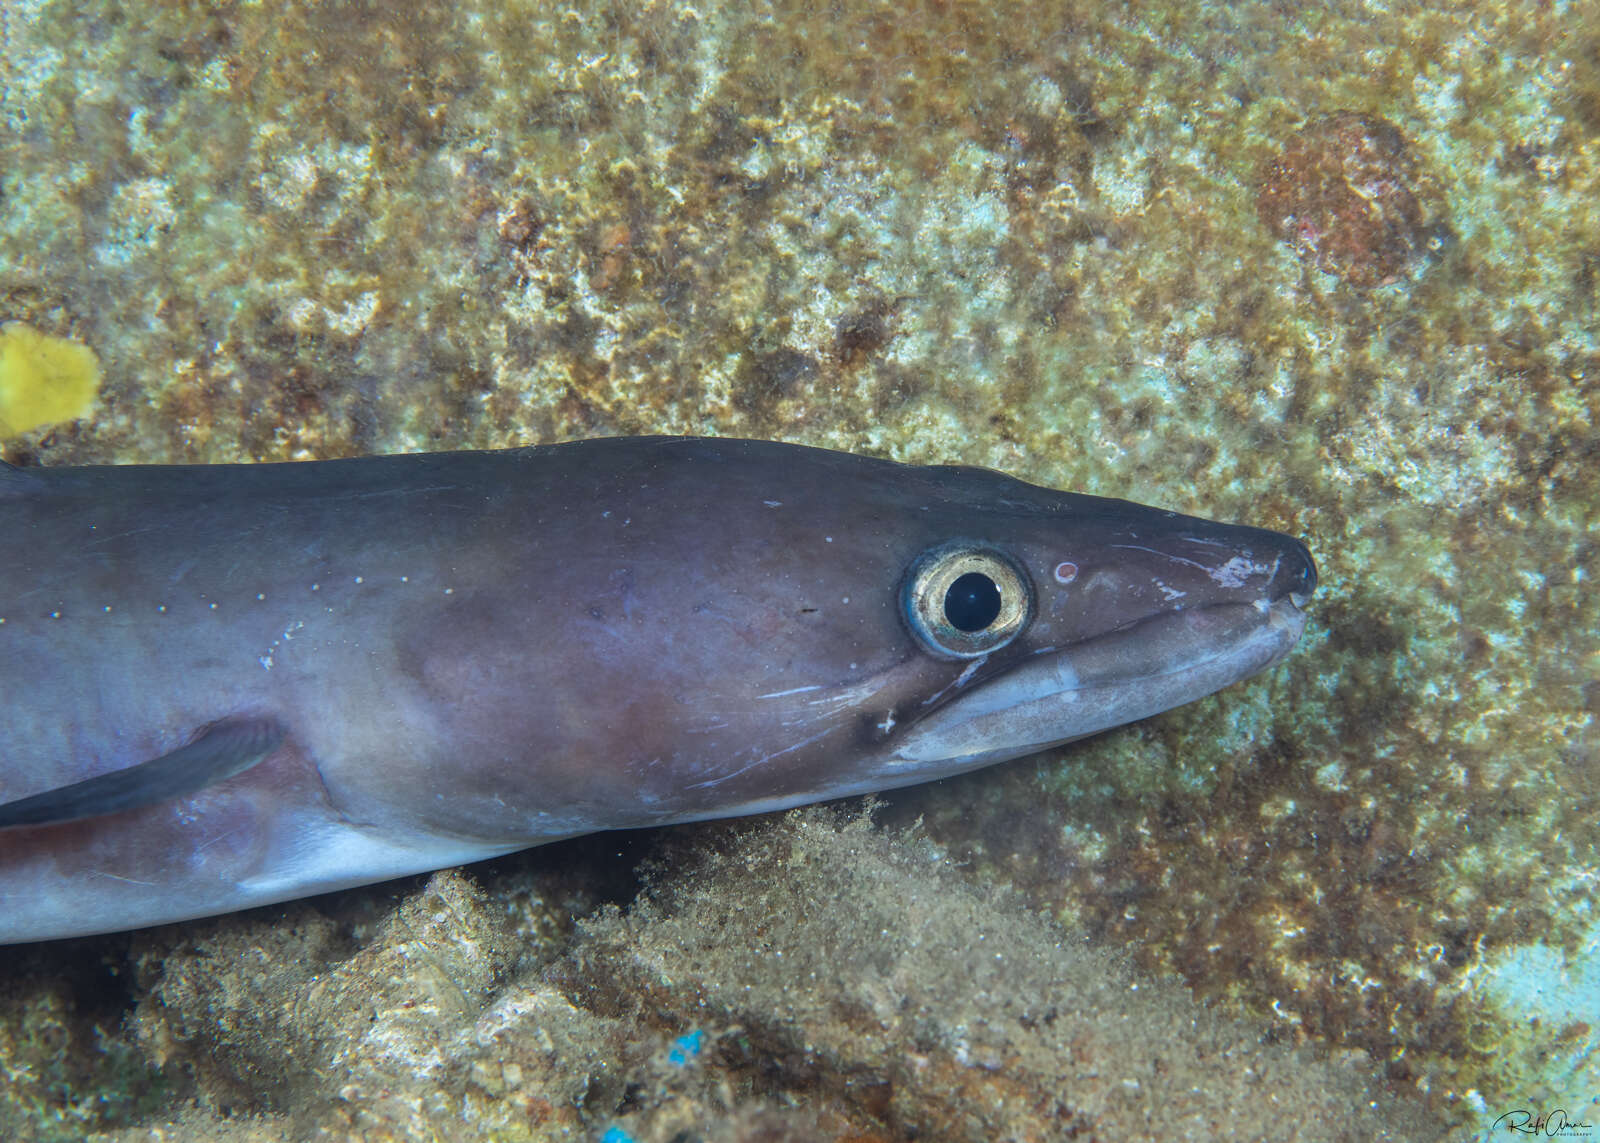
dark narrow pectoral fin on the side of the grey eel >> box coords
[0,717,285,829]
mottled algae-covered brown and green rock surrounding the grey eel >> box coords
[0,0,1600,1143]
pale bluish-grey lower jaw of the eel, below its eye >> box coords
[888,592,1306,776]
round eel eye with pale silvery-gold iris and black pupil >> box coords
[901,543,1034,660]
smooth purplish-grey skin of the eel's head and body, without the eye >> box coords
[0,437,1315,943]
